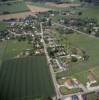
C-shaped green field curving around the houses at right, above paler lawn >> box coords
[64,33,99,72]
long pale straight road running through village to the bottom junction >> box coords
[40,23,62,99]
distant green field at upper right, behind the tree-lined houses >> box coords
[53,5,99,23]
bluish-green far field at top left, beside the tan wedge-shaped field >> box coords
[0,2,29,14]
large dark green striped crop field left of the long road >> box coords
[0,56,55,100]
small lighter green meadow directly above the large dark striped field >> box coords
[3,39,32,60]
